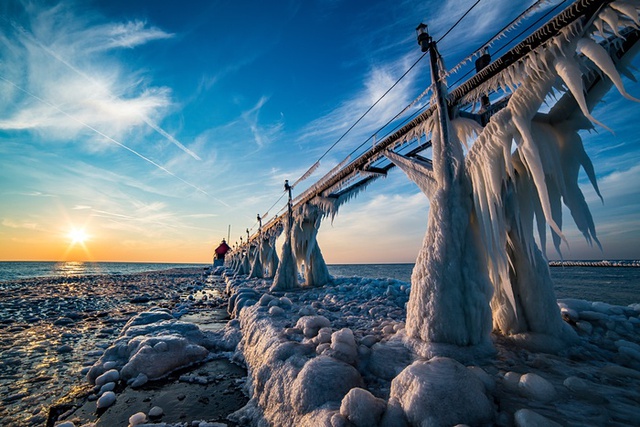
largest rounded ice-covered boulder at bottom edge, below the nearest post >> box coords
[391,357,493,426]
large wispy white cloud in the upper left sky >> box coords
[0,4,179,148]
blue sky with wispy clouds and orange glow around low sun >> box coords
[0,0,640,264]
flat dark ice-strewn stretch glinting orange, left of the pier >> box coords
[0,268,235,426]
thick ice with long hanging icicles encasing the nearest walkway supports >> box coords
[386,3,637,349]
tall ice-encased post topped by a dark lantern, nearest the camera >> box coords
[388,24,491,352]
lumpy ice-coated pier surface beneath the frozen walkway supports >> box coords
[216,275,640,426]
